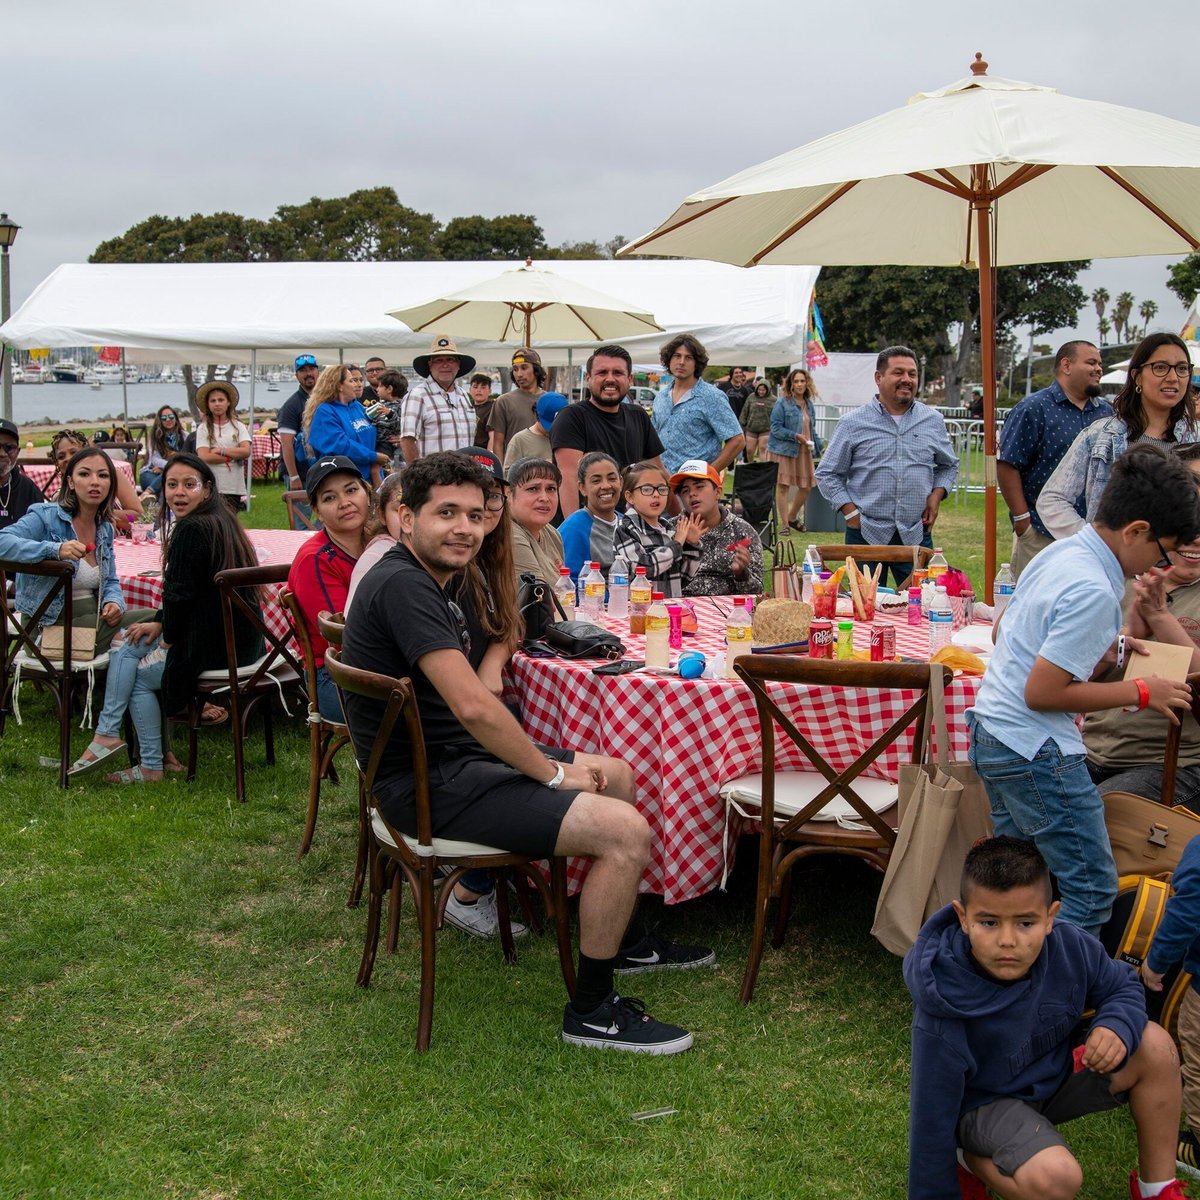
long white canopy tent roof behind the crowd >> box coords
[0,260,818,366]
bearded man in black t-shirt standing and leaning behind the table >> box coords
[550,346,662,516]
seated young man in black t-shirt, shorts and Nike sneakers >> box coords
[342,454,691,1055]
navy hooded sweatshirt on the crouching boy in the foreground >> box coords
[904,905,1146,1200]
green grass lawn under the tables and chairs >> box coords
[0,475,1152,1200]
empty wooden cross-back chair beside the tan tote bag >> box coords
[721,654,953,1004]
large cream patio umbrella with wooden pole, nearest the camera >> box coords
[620,54,1200,594]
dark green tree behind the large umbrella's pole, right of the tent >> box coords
[817,262,1090,402]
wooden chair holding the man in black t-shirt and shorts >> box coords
[325,647,575,1052]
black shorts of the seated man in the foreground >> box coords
[376,746,578,858]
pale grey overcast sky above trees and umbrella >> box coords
[0,0,1200,350]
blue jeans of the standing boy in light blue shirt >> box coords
[967,713,1117,934]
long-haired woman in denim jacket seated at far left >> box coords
[0,446,153,658]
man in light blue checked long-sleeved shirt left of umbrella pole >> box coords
[816,346,959,583]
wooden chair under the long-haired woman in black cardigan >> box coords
[186,563,305,804]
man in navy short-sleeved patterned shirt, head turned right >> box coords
[996,341,1112,578]
